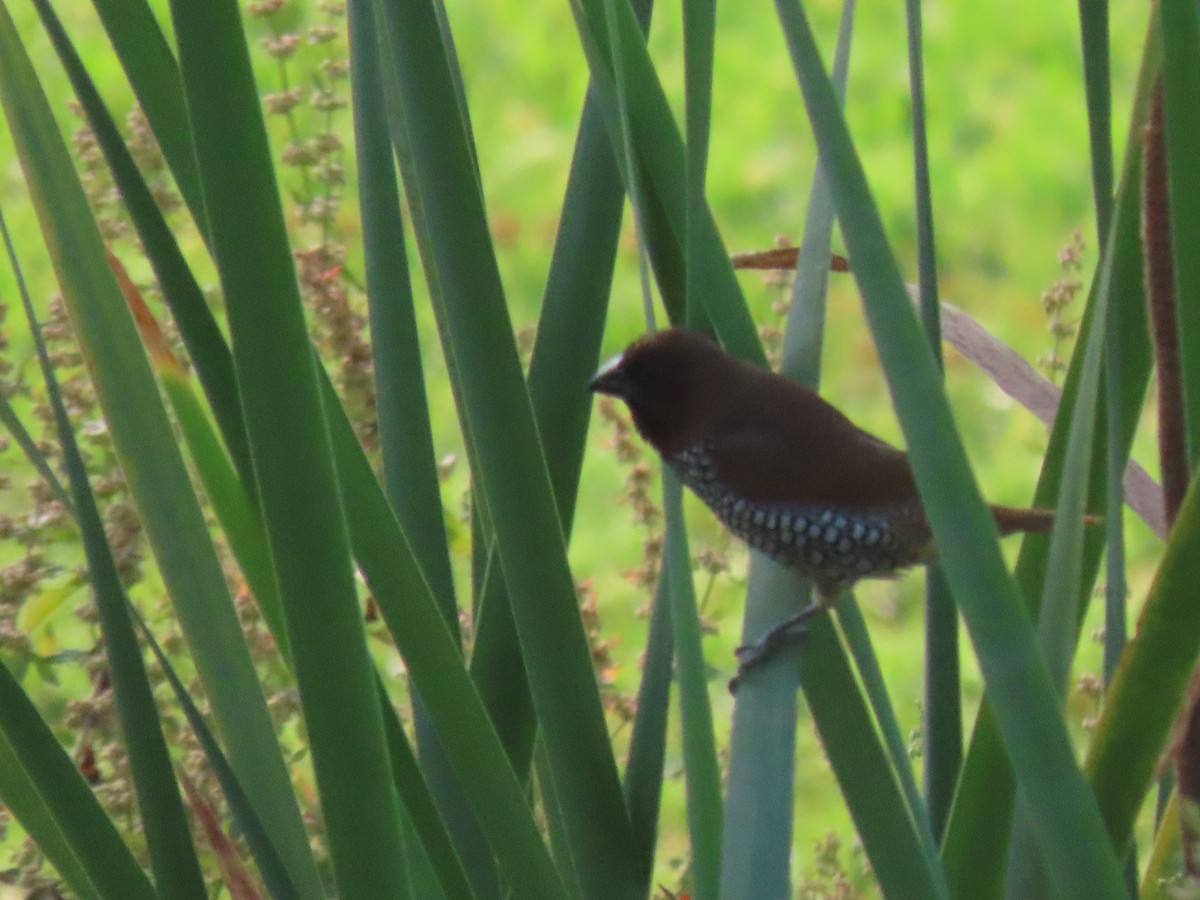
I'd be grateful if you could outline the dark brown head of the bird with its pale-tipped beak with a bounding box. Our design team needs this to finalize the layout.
[588,328,742,454]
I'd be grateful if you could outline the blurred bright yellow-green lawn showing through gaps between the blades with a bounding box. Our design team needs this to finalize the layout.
[0,0,1157,892]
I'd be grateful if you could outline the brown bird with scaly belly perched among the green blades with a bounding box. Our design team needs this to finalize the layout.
[588,329,1054,689]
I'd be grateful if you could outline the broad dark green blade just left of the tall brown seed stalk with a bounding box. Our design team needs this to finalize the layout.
[172,1,406,896]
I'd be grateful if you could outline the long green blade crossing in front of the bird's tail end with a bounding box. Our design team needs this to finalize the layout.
[776,0,1124,896]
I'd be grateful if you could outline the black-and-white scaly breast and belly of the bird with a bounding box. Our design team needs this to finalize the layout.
[667,445,932,589]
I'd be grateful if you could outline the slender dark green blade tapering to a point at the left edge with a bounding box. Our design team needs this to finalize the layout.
[0,206,206,898]
